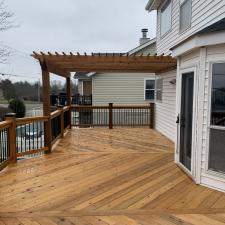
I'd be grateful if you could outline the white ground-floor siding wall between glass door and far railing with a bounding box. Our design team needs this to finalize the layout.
[155,70,177,142]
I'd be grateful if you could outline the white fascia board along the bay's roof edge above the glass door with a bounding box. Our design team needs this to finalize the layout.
[172,31,225,57]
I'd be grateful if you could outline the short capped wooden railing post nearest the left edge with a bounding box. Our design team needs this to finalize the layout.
[5,113,17,163]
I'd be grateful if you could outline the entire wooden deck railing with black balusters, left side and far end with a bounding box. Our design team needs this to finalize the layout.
[0,103,154,170]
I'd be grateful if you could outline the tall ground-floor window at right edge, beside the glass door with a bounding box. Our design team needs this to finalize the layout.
[209,63,225,172]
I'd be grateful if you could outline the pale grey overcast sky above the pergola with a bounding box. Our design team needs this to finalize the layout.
[0,0,156,81]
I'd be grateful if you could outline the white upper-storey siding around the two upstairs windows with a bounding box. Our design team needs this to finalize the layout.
[157,0,225,54]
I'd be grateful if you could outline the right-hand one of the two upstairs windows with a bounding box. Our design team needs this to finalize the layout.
[180,0,192,32]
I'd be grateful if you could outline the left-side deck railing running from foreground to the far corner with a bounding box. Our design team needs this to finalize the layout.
[0,107,70,170]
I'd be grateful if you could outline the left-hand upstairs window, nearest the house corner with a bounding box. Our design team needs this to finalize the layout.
[160,0,172,36]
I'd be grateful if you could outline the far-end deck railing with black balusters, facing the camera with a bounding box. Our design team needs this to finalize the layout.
[71,103,154,129]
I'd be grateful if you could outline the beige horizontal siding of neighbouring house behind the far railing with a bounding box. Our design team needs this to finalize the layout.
[92,73,155,105]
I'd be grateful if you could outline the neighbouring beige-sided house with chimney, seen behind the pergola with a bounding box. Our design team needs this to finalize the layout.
[75,29,156,105]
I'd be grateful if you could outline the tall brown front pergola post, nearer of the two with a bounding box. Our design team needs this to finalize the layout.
[40,61,52,153]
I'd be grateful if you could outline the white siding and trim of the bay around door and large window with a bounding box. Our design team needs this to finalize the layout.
[177,44,225,191]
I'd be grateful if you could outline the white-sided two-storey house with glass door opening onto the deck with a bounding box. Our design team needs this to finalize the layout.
[146,0,225,191]
